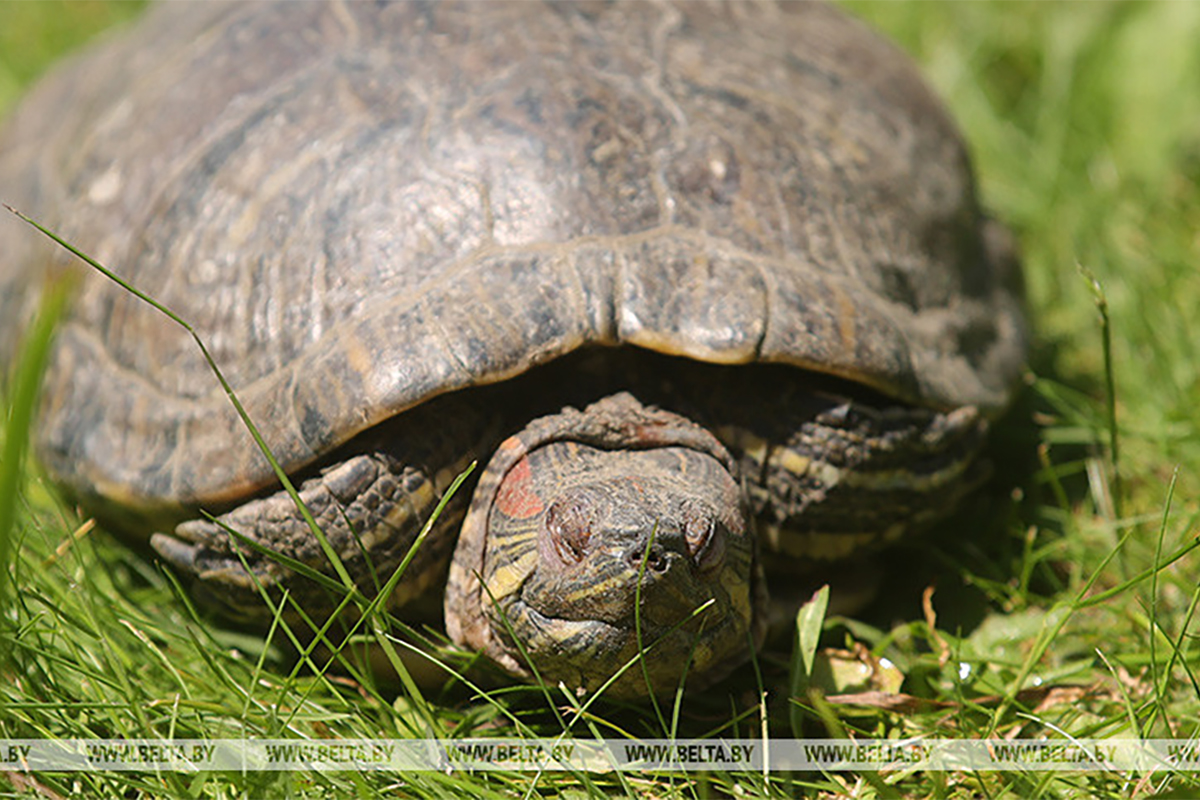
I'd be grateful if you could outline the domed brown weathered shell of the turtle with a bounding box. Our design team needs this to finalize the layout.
[0,2,1025,522]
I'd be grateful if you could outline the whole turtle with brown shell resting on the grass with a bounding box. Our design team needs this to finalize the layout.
[0,2,1027,697]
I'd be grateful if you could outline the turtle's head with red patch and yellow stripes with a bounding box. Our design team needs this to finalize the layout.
[446,393,762,696]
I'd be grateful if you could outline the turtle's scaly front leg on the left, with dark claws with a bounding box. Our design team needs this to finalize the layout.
[151,452,467,622]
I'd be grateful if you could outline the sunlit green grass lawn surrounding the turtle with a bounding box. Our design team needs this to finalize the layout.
[0,2,1200,798]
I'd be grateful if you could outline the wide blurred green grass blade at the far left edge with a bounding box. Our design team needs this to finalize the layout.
[0,278,71,657]
